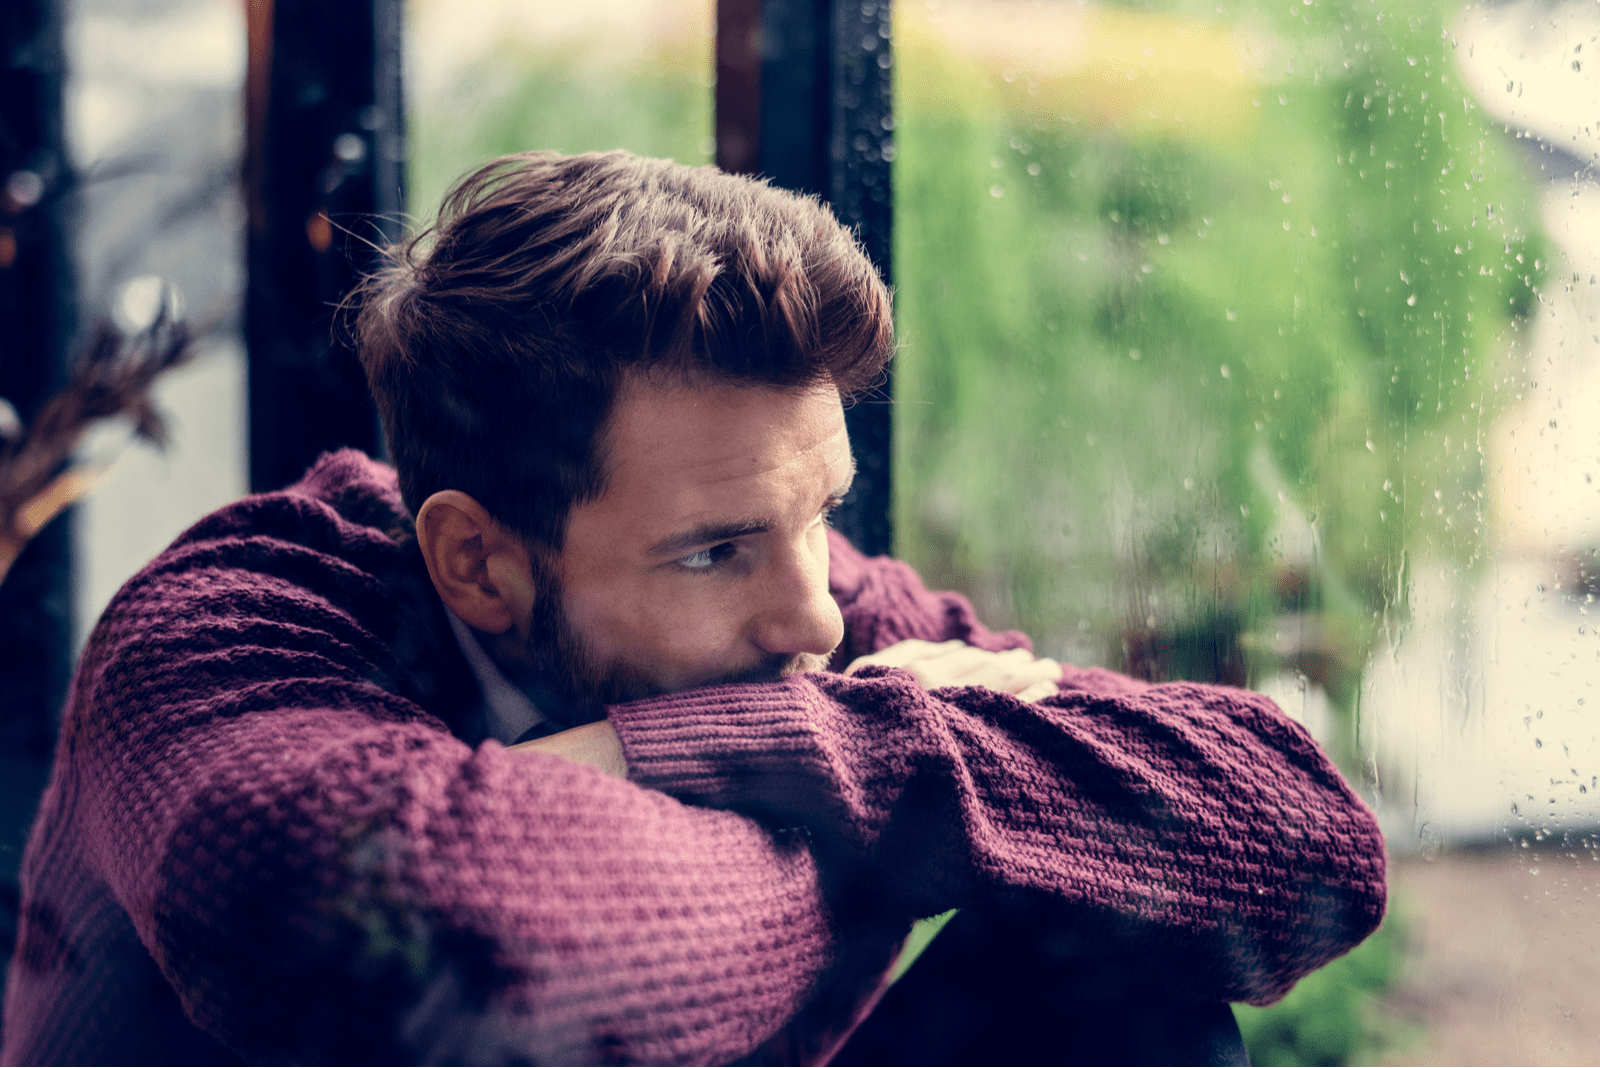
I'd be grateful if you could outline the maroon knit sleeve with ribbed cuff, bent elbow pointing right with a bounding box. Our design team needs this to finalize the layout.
[611,667,1384,1004]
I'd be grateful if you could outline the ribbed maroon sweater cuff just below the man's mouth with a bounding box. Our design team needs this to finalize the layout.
[606,676,830,819]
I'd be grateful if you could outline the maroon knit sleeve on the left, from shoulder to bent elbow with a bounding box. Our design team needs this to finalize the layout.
[58,502,834,1063]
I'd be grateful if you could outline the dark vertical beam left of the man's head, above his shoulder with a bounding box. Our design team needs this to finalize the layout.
[245,0,405,491]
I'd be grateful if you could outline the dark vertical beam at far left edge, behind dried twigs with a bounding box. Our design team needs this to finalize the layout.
[0,0,74,1004]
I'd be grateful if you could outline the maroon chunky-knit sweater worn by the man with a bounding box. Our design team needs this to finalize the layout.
[3,452,1384,1063]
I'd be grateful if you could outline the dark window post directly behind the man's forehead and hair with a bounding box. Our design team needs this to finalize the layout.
[717,0,894,553]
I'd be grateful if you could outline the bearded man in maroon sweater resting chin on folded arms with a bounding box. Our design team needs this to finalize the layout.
[3,153,1384,1063]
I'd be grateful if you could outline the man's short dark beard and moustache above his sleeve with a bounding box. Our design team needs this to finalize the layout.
[526,564,829,729]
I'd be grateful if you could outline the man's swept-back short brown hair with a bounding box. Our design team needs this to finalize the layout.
[355,152,894,550]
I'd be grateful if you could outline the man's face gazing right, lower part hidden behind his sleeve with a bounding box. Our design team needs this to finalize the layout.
[528,379,854,703]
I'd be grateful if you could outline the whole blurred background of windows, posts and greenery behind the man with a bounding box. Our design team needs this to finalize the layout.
[0,0,1600,1063]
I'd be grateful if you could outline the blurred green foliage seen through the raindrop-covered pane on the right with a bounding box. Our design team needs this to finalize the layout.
[896,0,1544,708]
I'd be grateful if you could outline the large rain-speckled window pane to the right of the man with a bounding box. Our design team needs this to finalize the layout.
[894,0,1600,1063]
